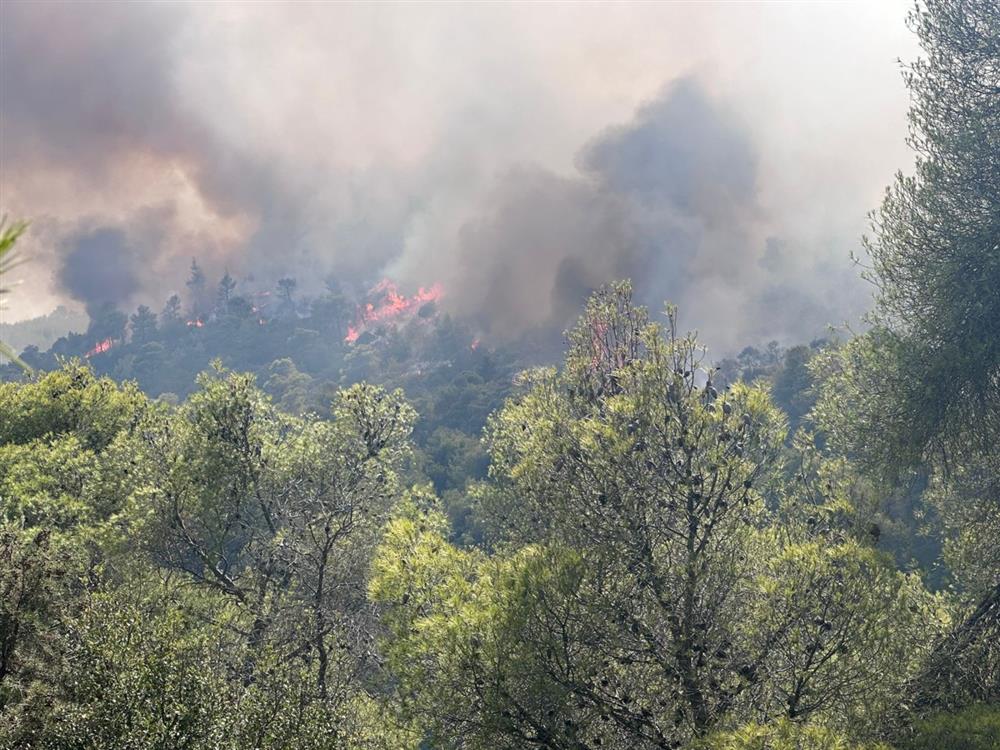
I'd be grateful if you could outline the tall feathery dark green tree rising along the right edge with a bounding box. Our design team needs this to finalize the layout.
[828,0,1000,467]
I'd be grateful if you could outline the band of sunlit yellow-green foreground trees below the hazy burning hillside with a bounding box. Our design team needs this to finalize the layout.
[0,285,998,748]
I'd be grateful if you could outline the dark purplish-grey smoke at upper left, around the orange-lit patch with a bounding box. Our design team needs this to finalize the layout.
[0,1,400,305]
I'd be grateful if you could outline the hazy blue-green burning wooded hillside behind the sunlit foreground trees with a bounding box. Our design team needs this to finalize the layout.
[2,261,832,559]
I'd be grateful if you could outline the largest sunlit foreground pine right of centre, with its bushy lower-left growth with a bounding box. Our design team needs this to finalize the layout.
[369,285,946,748]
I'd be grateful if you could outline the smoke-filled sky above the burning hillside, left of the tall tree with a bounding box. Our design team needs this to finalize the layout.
[0,1,915,350]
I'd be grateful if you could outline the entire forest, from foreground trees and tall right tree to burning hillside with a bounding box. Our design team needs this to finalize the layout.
[0,0,1000,750]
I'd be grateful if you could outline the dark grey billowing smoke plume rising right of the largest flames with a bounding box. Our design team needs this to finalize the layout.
[446,78,761,336]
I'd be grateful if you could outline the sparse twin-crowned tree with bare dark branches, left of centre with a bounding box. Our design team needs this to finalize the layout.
[133,371,414,746]
